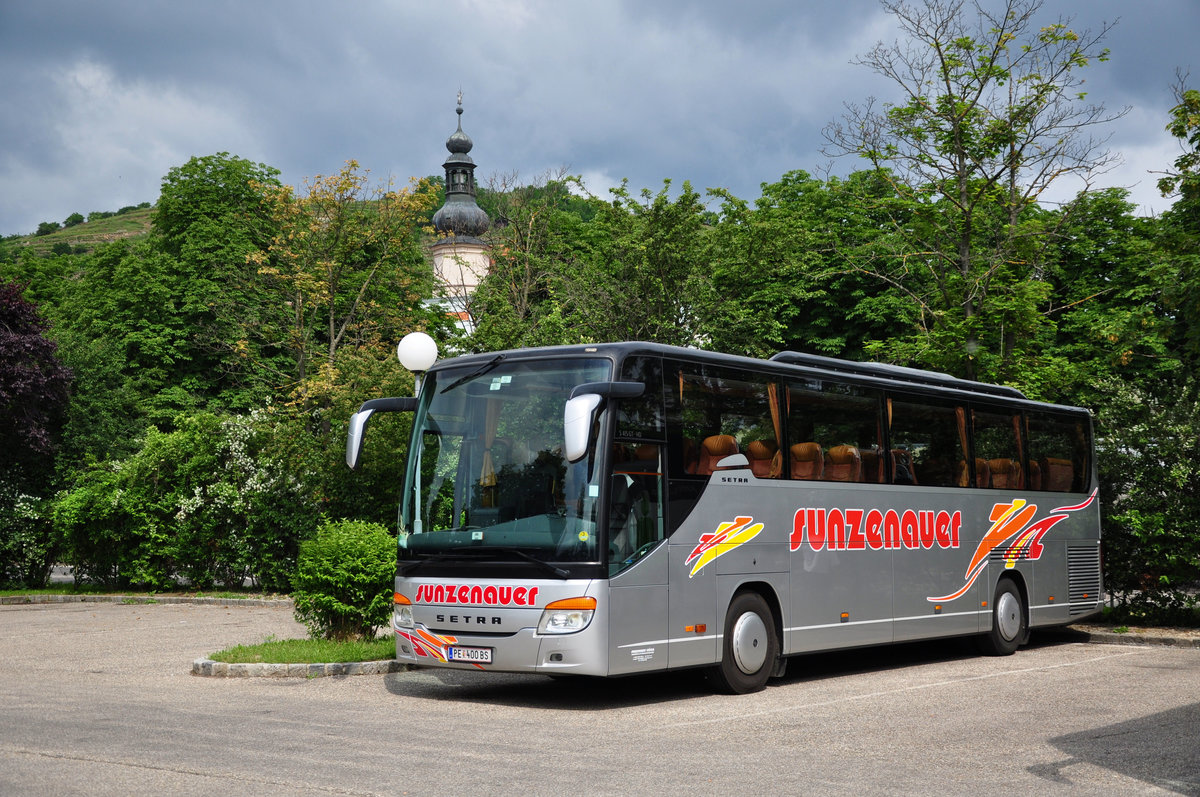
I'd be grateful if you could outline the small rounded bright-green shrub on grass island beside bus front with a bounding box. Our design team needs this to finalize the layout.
[292,520,396,640]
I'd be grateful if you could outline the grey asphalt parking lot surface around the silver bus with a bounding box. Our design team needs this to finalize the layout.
[0,604,1200,795]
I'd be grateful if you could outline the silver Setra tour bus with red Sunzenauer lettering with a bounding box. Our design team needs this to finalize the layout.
[347,342,1103,693]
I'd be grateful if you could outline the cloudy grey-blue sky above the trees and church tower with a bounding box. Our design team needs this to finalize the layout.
[0,0,1200,235]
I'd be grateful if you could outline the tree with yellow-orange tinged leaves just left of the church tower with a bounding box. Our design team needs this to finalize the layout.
[248,161,434,406]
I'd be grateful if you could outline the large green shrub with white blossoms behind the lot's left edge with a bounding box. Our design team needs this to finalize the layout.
[54,411,320,592]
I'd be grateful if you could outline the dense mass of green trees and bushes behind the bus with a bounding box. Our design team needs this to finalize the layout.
[0,1,1200,619]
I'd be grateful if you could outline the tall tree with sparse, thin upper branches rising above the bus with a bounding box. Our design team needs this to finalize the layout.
[826,0,1123,378]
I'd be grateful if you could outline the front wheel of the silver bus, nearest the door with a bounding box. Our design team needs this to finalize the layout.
[708,592,779,695]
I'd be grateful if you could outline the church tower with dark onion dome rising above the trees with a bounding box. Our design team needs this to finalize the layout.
[432,91,492,331]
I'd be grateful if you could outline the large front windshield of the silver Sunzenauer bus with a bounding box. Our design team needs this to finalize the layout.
[400,359,612,562]
